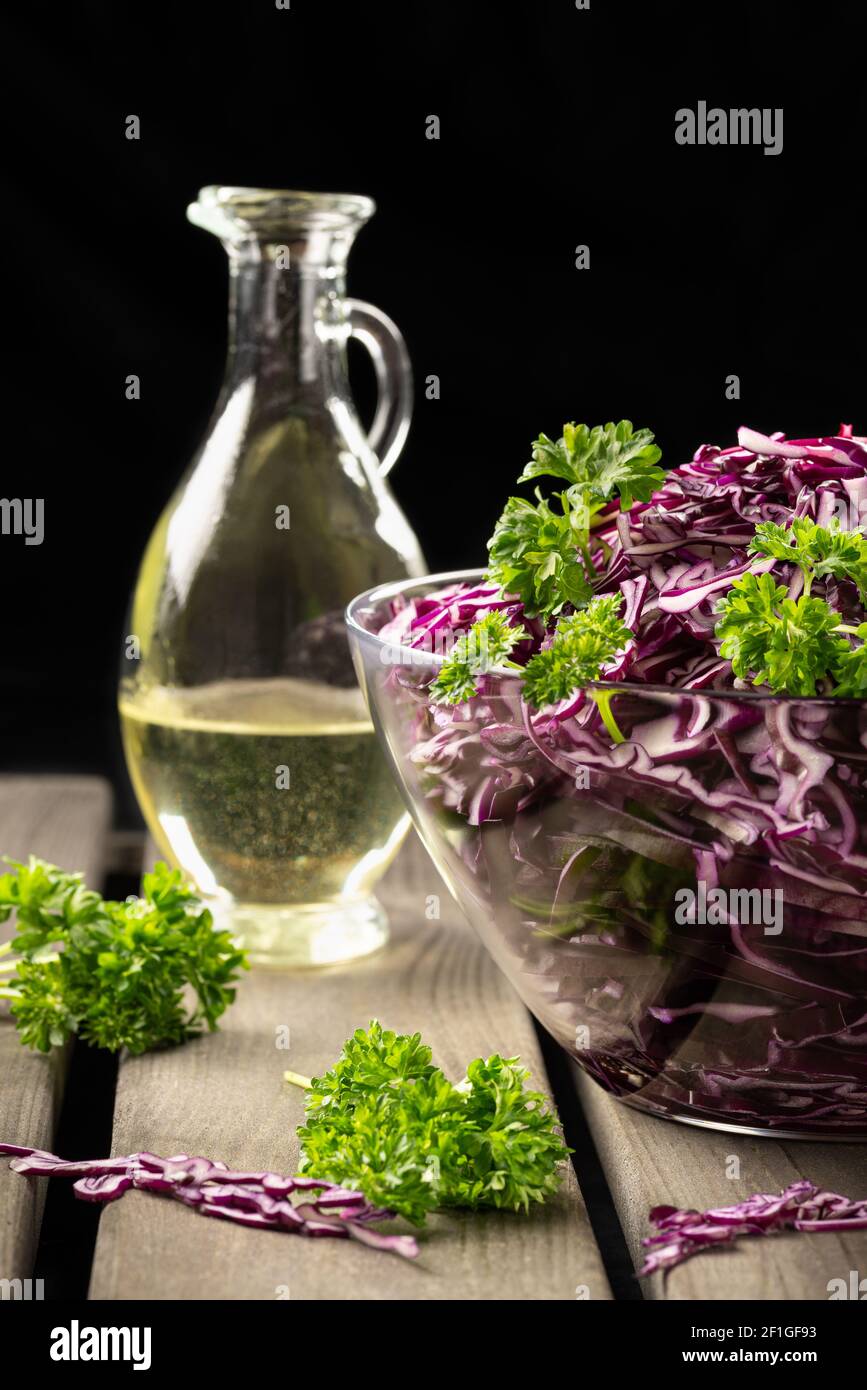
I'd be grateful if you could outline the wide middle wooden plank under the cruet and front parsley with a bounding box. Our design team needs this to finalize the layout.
[90,835,610,1300]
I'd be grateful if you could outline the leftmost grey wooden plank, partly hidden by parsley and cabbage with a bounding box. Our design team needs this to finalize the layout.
[0,777,111,1279]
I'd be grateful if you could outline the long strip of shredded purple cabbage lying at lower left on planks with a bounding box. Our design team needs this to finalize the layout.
[0,1144,418,1258]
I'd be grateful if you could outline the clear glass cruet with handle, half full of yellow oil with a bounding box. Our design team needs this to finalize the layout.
[119,188,425,965]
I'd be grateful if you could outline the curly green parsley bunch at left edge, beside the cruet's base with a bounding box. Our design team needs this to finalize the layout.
[0,856,246,1054]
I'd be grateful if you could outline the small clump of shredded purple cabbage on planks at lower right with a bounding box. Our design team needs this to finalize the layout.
[638,1179,867,1277]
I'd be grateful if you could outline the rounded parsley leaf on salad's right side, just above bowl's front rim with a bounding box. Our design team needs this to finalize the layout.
[716,574,849,695]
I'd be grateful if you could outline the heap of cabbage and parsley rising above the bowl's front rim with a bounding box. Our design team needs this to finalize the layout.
[379,421,867,706]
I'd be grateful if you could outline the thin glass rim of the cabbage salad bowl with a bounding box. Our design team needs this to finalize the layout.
[343,569,867,709]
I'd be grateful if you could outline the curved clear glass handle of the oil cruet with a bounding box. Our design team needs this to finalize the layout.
[343,299,413,478]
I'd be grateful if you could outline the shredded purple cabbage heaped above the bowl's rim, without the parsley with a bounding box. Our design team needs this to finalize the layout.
[379,425,867,686]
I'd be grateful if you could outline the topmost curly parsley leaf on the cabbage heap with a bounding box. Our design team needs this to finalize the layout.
[518,420,664,510]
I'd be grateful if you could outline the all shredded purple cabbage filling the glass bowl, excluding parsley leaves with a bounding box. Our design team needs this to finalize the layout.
[368,425,867,1137]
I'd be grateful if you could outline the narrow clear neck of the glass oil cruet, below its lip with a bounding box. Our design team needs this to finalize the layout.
[226,243,346,391]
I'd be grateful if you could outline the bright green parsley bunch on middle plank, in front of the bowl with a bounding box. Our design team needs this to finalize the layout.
[286,1020,570,1226]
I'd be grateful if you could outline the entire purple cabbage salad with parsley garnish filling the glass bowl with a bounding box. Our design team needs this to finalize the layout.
[378,421,867,1134]
